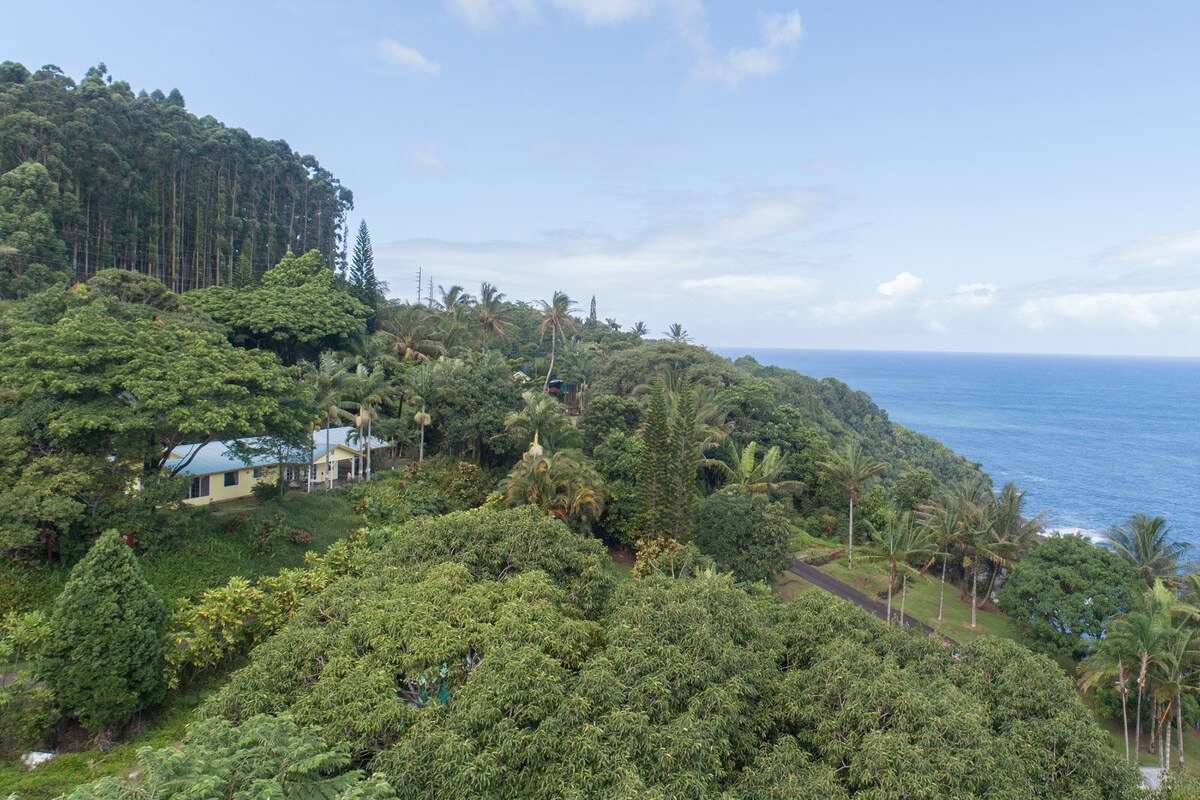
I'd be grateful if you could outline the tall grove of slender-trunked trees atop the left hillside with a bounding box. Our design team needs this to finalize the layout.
[0,61,354,297]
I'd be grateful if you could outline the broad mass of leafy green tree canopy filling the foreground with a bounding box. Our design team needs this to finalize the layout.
[187,510,1133,799]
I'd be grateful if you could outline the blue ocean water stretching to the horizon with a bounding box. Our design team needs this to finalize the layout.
[718,348,1200,546]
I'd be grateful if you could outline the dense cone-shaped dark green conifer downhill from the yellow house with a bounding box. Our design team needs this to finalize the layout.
[41,530,167,730]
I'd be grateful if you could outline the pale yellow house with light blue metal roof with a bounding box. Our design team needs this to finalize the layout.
[167,426,390,505]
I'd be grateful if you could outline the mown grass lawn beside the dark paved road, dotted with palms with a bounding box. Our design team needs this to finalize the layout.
[821,559,1018,644]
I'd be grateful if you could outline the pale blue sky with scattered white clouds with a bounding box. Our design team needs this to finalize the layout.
[0,0,1200,357]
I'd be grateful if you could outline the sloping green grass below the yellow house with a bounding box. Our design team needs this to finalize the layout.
[0,492,361,618]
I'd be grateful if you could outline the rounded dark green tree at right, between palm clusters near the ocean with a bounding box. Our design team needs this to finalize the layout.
[996,536,1141,660]
